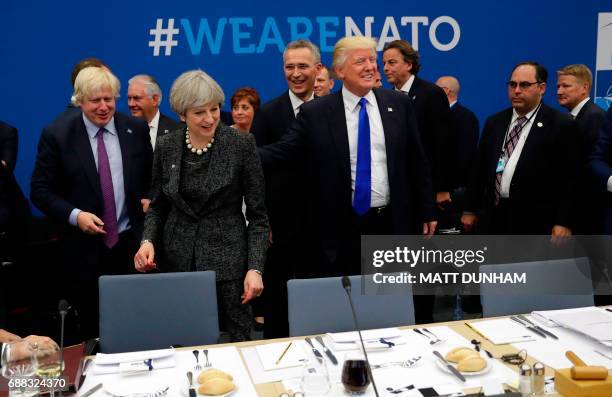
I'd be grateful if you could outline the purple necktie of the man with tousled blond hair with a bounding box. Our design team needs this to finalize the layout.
[97,128,119,248]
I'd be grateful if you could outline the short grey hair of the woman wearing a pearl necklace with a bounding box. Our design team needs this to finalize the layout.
[170,69,225,115]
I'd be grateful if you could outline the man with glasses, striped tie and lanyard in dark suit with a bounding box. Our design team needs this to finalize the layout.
[461,62,584,238]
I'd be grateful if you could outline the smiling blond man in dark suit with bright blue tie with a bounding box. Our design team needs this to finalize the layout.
[260,37,436,318]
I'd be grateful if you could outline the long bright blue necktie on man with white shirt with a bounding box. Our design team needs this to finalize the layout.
[353,98,372,216]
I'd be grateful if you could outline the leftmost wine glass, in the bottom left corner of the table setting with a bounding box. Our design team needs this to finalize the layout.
[0,340,38,396]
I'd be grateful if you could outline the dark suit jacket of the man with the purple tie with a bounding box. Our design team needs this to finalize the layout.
[30,111,152,278]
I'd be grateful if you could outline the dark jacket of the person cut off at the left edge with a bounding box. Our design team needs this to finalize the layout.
[0,121,30,232]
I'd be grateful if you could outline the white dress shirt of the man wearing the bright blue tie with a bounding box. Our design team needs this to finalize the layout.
[342,86,389,208]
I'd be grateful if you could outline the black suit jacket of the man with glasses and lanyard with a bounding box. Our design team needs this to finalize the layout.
[466,104,581,234]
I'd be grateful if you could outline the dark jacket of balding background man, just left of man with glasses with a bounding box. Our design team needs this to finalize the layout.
[451,102,480,187]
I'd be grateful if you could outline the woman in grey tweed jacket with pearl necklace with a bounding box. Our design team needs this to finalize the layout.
[134,70,268,341]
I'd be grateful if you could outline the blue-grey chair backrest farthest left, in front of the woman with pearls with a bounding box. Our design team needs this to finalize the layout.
[99,271,219,353]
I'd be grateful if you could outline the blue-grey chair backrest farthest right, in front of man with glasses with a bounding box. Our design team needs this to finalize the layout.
[480,258,594,317]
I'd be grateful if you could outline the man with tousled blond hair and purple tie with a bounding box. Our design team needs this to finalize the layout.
[31,67,152,339]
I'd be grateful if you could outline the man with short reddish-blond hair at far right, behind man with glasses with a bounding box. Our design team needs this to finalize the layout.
[557,64,606,235]
